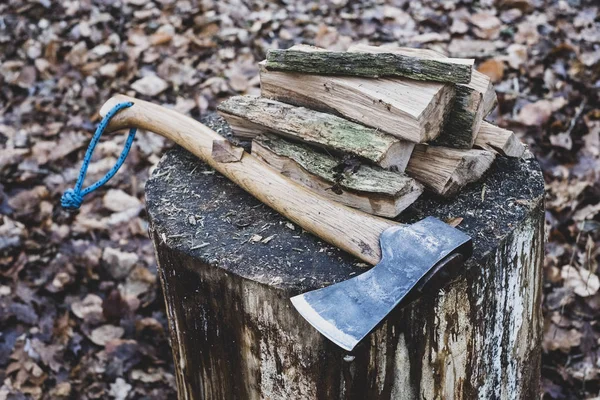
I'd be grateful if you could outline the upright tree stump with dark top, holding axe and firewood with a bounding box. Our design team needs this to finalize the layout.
[146,117,544,399]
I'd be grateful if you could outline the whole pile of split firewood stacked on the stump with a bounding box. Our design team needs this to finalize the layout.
[218,45,524,217]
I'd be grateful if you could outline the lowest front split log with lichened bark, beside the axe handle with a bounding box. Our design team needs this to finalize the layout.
[252,135,423,218]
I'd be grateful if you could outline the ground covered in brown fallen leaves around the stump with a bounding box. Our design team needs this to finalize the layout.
[0,0,600,399]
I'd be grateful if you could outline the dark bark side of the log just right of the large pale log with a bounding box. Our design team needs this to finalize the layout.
[431,85,483,149]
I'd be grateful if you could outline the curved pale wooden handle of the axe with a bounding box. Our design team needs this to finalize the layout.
[100,95,397,265]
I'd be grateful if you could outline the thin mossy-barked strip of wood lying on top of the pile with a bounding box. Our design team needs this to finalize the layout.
[266,50,473,83]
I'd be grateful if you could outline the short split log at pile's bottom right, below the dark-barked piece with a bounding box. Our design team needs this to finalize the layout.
[406,145,495,196]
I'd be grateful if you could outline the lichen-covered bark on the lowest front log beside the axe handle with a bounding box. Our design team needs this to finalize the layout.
[254,134,415,197]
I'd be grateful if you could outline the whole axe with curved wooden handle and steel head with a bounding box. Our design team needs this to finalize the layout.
[100,95,472,350]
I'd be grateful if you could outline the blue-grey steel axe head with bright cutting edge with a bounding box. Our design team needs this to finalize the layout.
[291,217,472,351]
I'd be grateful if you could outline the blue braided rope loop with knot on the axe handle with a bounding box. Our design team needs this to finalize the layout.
[60,101,137,210]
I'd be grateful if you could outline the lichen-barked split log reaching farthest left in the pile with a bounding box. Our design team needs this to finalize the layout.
[218,96,414,171]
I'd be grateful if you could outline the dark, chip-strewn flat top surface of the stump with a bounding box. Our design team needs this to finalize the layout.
[146,115,544,293]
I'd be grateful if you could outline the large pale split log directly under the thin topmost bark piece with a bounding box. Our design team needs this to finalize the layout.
[259,61,455,143]
